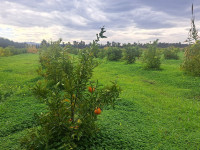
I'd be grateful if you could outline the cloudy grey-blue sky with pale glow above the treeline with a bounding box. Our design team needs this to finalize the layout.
[0,0,200,43]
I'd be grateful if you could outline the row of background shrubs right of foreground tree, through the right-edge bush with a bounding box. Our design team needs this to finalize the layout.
[94,40,200,76]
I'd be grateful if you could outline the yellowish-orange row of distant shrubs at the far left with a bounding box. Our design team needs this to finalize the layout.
[0,46,38,57]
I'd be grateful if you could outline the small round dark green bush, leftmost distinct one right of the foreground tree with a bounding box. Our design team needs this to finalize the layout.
[107,47,122,61]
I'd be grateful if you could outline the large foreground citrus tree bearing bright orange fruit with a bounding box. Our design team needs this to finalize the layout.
[21,29,120,149]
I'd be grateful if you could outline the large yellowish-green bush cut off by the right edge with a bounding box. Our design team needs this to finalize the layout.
[181,41,200,76]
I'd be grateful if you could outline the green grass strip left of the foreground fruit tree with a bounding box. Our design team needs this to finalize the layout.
[0,54,45,150]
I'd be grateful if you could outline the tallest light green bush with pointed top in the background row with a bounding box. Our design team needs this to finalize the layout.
[143,40,161,69]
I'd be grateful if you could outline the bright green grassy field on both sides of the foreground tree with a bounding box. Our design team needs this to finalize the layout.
[0,54,200,150]
